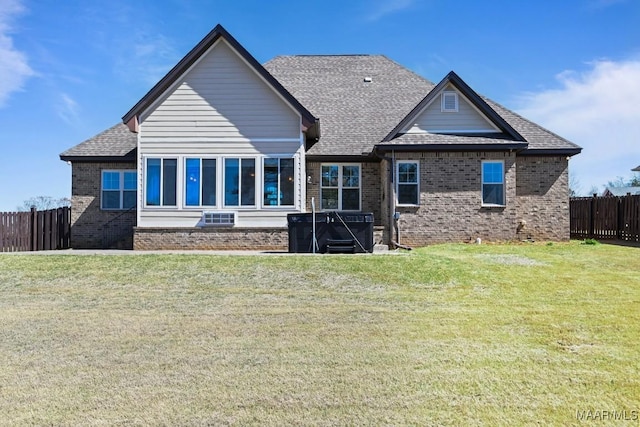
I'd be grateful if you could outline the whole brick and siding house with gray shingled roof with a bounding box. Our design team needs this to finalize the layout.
[60,25,581,250]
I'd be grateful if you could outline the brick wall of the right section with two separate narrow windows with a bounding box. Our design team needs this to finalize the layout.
[388,152,517,246]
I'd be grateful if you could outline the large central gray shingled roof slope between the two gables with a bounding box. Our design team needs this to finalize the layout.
[264,55,435,156]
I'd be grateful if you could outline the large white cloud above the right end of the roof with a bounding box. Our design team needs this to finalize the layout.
[518,59,640,194]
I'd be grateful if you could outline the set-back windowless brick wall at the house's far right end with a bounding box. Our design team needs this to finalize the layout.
[516,156,569,240]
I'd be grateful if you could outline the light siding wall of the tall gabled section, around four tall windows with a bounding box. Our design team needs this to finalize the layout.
[138,39,306,228]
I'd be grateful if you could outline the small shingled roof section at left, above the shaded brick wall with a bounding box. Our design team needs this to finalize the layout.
[60,123,138,162]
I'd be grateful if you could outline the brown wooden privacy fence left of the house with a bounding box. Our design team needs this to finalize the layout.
[0,207,71,252]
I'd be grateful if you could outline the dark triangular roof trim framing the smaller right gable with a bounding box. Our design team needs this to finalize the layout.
[383,71,525,142]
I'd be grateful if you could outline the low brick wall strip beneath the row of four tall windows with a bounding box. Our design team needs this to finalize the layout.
[133,227,289,251]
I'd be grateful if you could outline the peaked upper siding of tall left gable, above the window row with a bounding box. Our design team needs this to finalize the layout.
[140,40,300,141]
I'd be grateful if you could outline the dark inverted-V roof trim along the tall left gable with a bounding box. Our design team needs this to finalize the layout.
[122,24,319,138]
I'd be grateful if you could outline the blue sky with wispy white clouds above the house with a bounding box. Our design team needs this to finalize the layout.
[0,0,640,211]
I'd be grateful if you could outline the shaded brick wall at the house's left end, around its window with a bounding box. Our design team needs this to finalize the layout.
[71,162,136,249]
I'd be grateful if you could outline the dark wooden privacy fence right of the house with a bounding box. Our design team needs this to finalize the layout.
[569,195,640,242]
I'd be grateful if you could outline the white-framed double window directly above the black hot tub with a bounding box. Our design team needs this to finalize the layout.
[320,164,360,211]
